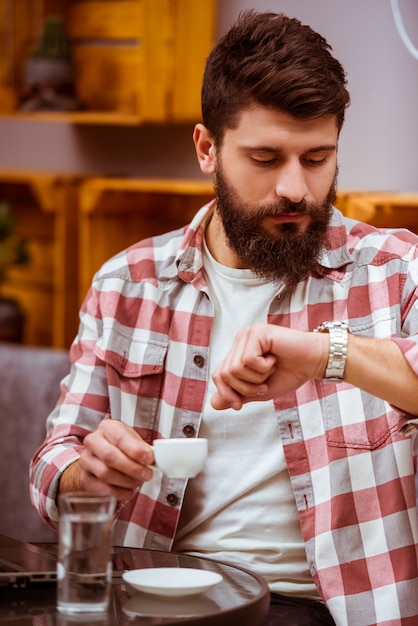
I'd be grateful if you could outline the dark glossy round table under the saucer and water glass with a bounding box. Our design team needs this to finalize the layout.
[0,548,270,626]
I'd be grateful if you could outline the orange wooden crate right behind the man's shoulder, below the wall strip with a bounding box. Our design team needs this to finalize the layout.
[79,178,214,299]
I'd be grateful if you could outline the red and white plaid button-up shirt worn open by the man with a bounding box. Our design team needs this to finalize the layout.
[31,205,418,626]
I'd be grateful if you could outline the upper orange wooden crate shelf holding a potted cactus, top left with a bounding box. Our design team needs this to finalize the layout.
[0,0,216,124]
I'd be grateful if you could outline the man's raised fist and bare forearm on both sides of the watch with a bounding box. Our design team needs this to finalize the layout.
[211,323,418,416]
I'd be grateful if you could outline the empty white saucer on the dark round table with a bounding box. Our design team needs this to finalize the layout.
[122,567,222,597]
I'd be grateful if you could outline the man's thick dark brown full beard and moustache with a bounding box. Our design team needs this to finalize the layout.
[215,163,337,283]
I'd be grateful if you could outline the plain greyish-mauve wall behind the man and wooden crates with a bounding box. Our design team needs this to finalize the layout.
[0,0,418,190]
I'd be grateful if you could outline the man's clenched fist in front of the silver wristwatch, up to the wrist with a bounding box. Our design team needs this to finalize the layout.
[211,323,329,409]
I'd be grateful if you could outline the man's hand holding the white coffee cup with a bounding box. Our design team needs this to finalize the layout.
[67,419,154,500]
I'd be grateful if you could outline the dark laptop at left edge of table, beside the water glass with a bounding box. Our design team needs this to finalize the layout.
[0,534,57,589]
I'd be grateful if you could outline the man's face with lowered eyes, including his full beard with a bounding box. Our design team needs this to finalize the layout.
[204,108,338,282]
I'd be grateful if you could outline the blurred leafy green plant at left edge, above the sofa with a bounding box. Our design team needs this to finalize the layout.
[0,200,30,284]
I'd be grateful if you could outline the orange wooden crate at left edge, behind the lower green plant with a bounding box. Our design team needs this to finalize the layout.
[0,170,79,347]
